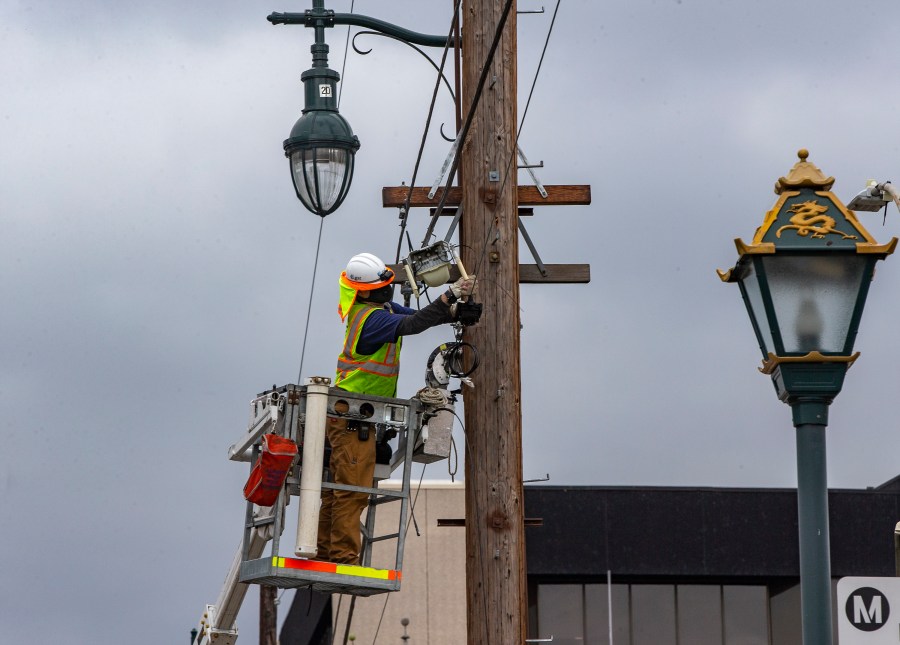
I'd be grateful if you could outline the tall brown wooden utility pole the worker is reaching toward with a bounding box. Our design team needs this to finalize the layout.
[460,0,528,645]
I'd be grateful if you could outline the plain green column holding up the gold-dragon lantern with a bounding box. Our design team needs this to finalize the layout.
[791,398,833,645]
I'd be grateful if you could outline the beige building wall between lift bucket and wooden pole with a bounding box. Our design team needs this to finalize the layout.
[332,481,466,645]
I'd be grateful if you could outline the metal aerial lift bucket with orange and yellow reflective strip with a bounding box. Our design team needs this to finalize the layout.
[230,377,451,596]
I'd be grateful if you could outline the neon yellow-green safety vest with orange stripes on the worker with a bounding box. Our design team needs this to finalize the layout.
[334,303,401,397]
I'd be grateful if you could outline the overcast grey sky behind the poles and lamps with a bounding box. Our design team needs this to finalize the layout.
[0,0,900,645]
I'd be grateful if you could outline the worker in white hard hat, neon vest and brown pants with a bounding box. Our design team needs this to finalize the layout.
[316,253,481,564]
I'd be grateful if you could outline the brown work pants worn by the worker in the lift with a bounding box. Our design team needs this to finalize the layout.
[316,417,375,564]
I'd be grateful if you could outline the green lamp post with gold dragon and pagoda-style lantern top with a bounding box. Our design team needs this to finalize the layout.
[718,150,897,645]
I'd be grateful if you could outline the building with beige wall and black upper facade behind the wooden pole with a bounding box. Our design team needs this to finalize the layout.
[281,478,900,645]
